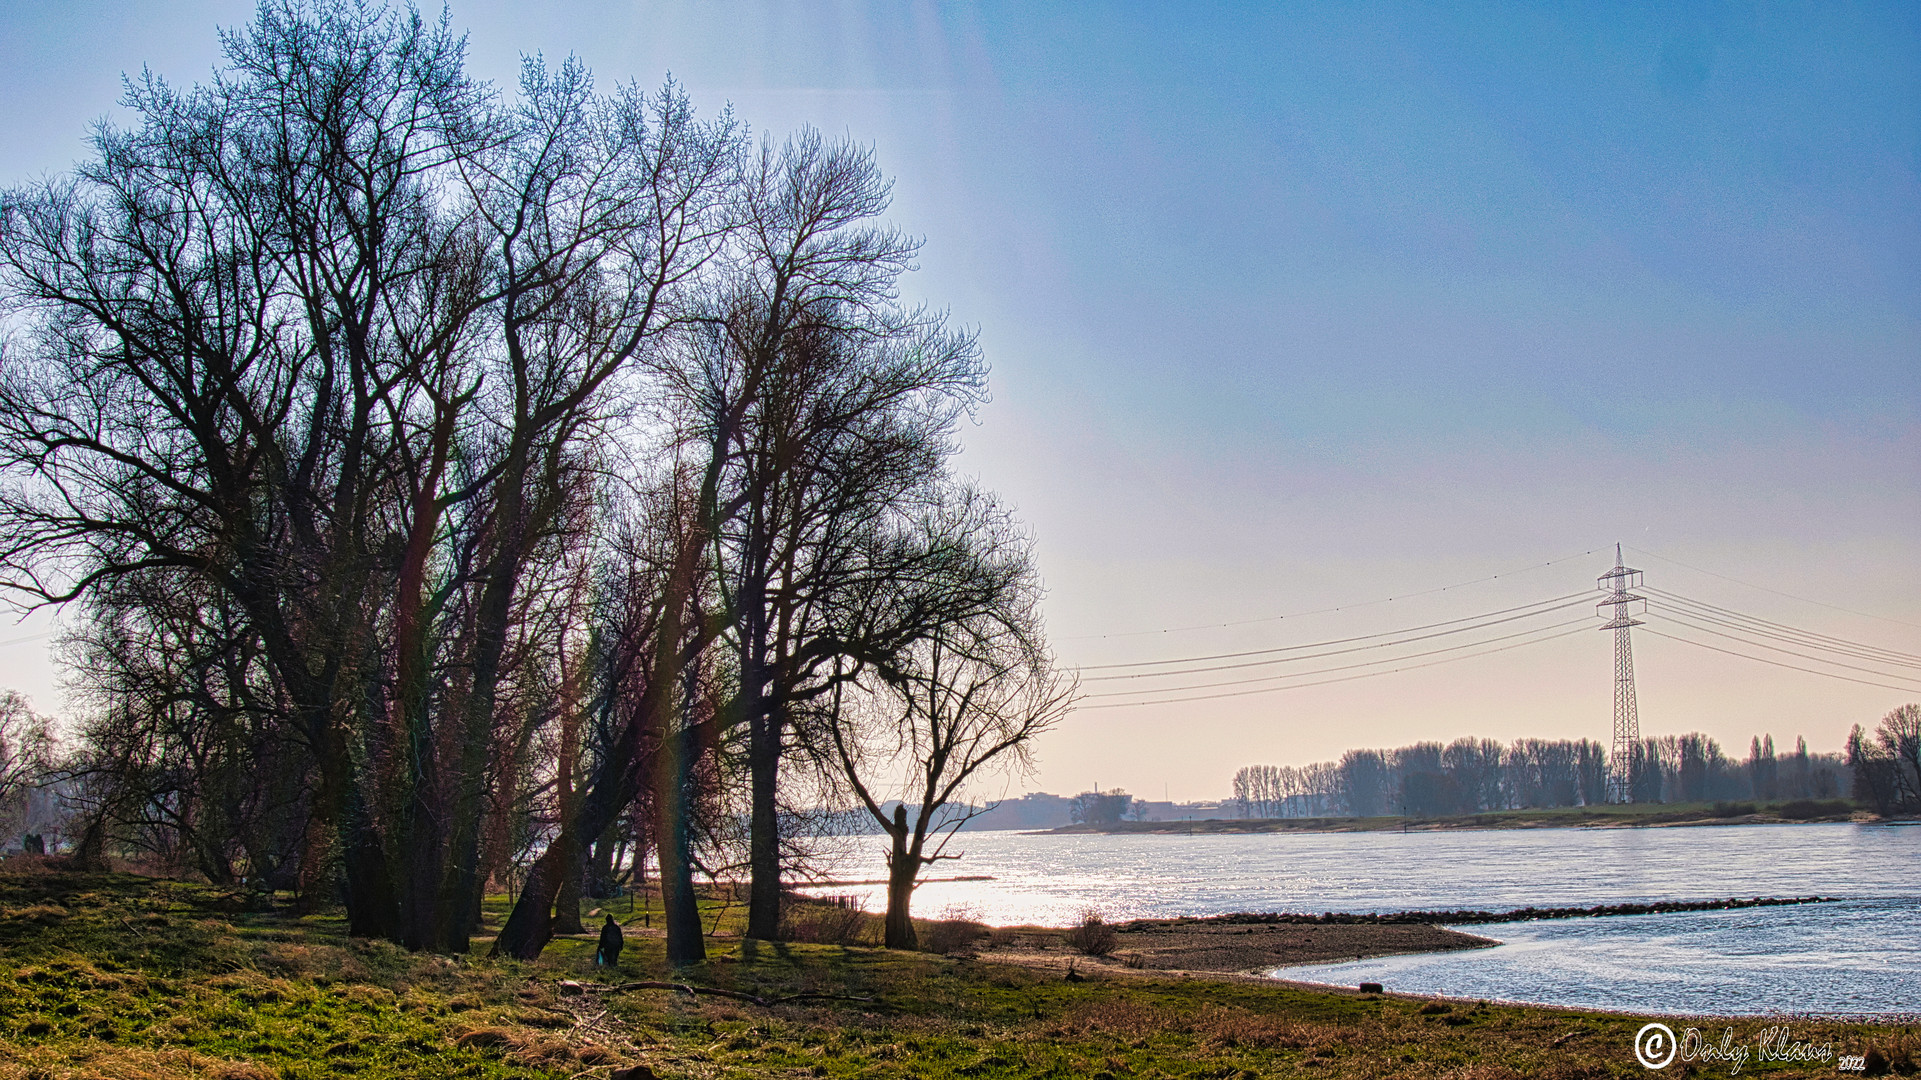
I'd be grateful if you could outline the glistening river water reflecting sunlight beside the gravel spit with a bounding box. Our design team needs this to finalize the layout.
[799,824,1921,1015]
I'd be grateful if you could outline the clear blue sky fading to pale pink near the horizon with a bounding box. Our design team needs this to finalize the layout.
[0,0,1921,799]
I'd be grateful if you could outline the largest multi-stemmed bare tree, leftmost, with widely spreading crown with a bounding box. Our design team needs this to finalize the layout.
[0,0,738,951]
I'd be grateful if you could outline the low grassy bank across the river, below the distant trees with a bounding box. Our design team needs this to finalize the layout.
[1051,799,1873,834]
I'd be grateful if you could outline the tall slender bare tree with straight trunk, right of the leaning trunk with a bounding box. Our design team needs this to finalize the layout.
[699,129,985,938]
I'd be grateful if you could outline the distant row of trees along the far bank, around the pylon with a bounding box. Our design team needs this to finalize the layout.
[1233,722,1842,817]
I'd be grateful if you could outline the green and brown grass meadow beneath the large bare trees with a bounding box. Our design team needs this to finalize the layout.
[0,861,1915,1080]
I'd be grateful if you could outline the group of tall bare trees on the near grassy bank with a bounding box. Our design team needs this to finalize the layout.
[0,0,1072,963]
